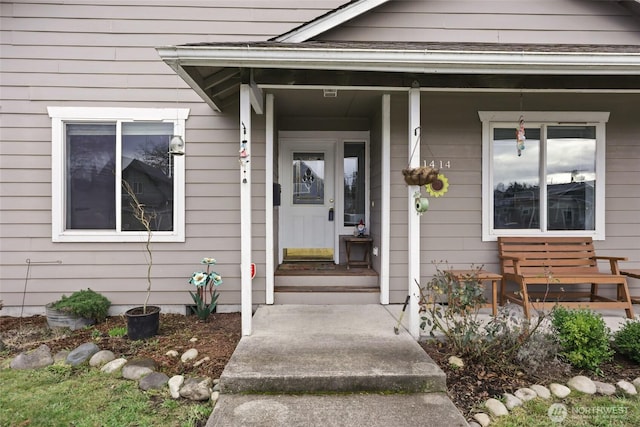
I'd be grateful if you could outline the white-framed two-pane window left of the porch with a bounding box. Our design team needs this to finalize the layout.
[49,107,188,241]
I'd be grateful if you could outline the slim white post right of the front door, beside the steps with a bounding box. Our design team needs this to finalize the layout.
[380,93,391,304]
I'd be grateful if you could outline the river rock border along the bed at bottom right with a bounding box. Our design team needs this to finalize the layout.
[469,375,640,427]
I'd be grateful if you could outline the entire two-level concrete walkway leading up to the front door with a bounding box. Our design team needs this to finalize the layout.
[207,304,467,427]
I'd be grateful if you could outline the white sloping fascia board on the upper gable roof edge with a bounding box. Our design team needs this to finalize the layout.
[273,0,389,43]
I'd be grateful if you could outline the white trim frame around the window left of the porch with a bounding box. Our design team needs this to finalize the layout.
[47,107,189,242]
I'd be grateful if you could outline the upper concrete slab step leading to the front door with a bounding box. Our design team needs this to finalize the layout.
[220,305,446,393]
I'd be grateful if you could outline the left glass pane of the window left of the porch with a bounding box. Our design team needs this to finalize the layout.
[65,123,116,230]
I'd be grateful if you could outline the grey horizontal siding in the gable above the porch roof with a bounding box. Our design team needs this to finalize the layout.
[318,0,640,45]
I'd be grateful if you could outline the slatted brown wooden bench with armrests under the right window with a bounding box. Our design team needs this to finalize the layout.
[498,237,633,319]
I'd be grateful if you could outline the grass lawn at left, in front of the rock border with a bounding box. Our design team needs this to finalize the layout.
[0,365,212,427]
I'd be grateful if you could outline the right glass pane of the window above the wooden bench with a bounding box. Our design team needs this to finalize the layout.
[546,126,596,230]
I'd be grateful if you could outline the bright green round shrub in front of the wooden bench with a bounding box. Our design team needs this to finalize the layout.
[551,306,614,373]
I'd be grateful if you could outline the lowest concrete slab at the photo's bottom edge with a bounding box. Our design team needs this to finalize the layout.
[206,393,468,427]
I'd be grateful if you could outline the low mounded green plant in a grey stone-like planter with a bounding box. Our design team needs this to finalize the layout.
[45,288,111,331]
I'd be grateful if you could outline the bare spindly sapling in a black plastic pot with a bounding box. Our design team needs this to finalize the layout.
[122,180,160,340]
